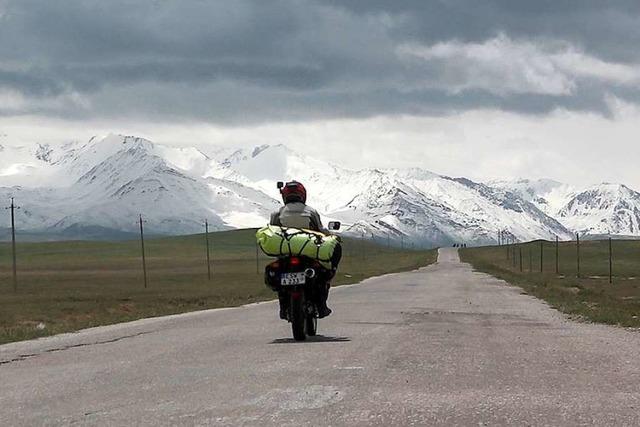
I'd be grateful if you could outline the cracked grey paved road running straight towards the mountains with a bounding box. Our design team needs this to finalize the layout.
[0,250,640,426]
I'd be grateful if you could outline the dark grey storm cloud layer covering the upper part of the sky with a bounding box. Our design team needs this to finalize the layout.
[0,0,640,124]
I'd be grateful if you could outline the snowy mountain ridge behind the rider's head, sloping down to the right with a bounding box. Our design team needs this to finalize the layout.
[218,146,570,244]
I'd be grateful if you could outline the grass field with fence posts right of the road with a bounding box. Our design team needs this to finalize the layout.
[460,240,640,327]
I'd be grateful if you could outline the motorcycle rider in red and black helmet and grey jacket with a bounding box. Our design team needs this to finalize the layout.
[270,181,340,319]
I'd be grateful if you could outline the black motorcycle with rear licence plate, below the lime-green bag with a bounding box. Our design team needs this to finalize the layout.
[264,221,340,341]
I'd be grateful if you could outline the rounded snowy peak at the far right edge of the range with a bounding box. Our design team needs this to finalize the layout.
[558,184,640,236]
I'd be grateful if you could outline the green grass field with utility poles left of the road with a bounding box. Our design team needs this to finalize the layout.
[0,230,436,343]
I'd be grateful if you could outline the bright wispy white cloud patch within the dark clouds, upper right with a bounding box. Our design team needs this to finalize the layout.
[397,34,640,95]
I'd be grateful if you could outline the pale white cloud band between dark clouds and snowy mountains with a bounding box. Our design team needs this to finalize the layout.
[0,97,640,190]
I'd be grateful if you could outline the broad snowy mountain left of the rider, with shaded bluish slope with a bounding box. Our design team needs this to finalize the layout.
[0,135,278,234]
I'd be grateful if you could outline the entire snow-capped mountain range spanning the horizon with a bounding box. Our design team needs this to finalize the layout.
[0,135,640,244]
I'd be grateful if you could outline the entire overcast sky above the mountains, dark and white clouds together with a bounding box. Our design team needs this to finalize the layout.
[0,0,640,189]
